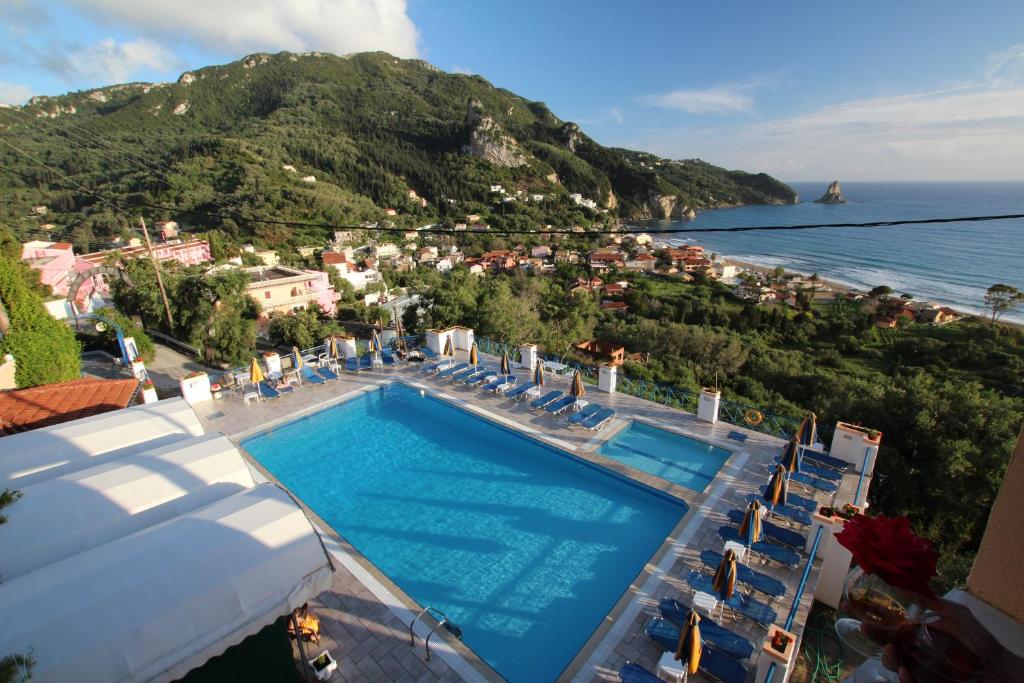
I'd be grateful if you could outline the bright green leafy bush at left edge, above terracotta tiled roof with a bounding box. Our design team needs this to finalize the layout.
[0,257,81,387]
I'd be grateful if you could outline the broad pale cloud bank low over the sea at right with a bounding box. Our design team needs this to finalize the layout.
[630,83,1024,180]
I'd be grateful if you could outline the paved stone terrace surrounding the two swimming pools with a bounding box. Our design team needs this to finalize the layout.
[197,354,856,683]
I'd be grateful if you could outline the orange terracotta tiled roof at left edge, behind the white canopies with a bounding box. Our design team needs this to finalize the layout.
[0,378,138,436]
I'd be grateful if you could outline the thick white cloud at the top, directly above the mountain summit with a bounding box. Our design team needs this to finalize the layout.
[69,0,419,57]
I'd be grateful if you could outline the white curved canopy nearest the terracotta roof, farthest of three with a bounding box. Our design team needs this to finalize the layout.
[0,398,203,488]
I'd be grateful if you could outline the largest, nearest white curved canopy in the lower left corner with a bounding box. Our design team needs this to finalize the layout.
[0,484,331,683]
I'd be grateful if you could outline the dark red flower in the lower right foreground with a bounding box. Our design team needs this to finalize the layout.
[836,515,938,596]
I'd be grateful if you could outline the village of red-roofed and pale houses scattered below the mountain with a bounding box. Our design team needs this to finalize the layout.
[22,208,958,329]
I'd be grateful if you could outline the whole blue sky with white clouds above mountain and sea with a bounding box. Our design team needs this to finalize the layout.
[0,0,1024,181]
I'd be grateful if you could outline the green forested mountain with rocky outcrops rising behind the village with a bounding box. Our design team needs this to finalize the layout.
[0,52,796,247]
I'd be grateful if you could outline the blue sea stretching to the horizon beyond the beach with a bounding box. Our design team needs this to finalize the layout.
[644,181,1024,323]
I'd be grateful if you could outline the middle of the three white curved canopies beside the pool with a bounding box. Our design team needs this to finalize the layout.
[0,433,255,581]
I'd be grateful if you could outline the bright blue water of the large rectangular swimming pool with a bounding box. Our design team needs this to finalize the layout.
[243,384,686,682]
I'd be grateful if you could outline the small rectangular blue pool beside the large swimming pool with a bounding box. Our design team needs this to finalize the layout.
[597,420,730,492]
